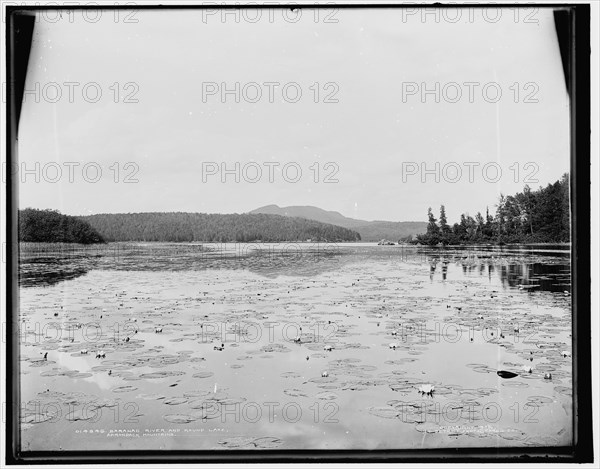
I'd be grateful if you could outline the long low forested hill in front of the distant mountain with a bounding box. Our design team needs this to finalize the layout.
[80,212,360,242]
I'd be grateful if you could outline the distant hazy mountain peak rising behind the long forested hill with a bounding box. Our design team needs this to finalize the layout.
[249,205,427,241]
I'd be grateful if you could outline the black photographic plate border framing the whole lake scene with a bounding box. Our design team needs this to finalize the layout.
[3,3,597,464]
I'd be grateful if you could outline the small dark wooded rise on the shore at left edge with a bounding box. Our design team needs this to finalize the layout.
[19,208,104,244]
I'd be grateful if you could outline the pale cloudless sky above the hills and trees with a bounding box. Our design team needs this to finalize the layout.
[18,8,570,223]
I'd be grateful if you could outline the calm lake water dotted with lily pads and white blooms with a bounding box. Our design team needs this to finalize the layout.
[19,243,573,451]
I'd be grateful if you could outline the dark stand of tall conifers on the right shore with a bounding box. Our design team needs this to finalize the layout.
[413,174,570,245]
